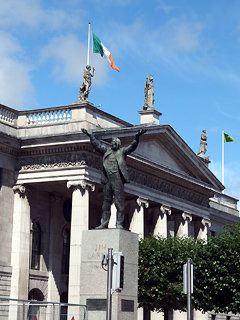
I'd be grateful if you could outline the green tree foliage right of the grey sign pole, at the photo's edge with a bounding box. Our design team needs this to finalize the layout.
[193,223,240,313]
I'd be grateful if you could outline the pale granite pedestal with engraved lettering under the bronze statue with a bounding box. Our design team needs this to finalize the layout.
[80,229,138,320]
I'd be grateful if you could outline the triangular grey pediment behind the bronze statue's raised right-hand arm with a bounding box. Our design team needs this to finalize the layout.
[129,125,224,190]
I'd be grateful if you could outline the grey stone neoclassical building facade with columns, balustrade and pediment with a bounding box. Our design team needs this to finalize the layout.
[0,101,239,320]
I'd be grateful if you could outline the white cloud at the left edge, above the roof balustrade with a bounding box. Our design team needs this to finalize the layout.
[0,33,35,109]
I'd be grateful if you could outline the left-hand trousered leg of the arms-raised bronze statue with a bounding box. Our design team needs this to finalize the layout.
[97,181,112,229]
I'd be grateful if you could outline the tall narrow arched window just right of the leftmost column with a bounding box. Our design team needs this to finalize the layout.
[31,222,41,270]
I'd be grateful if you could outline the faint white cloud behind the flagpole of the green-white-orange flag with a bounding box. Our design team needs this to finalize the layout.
[41,34,108,85]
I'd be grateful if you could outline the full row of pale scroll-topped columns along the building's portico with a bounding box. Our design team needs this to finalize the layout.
[11,179,211,320]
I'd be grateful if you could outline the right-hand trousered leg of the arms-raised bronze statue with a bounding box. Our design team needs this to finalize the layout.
[113,175,125,229]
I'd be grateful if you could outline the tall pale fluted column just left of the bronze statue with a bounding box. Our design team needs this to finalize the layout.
[67,180,95,304]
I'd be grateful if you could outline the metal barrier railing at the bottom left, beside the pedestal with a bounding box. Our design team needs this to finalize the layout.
[0,297,88,320]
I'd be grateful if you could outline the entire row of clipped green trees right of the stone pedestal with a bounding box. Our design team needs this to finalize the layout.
[138,224,240,313]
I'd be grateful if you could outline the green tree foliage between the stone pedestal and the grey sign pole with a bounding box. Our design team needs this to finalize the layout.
[138,235,202,312]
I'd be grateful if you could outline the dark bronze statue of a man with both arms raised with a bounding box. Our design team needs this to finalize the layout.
[82,129,147,229]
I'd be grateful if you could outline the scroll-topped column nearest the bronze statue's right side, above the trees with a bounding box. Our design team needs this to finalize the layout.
[129,197,149,238]
